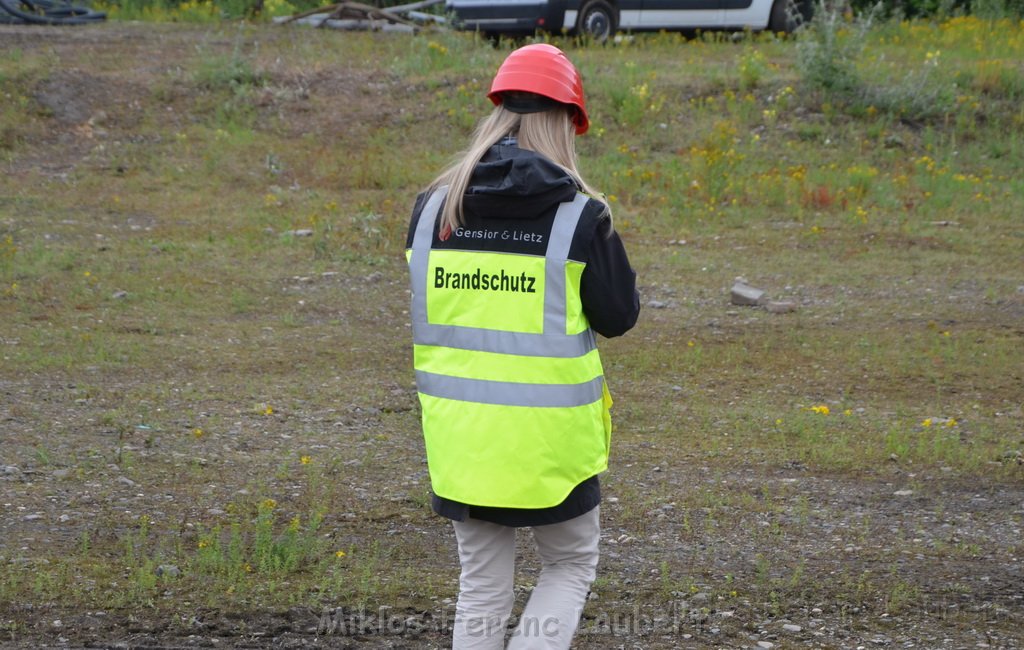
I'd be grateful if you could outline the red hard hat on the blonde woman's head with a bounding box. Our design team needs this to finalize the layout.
[487,43,590,135]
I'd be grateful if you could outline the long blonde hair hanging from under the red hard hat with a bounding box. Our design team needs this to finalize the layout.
[428,104,611,232]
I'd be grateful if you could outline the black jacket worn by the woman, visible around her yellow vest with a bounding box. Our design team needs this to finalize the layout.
[407,139,640,526]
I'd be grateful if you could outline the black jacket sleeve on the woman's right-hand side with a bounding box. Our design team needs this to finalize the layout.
[580,218,640,338]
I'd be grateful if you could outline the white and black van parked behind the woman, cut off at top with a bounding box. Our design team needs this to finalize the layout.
[445,0,812,41]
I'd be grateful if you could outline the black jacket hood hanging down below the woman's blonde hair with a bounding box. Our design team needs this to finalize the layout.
[463,140,578,219]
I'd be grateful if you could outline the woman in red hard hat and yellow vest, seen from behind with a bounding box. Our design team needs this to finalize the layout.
[407,44,640,650]
